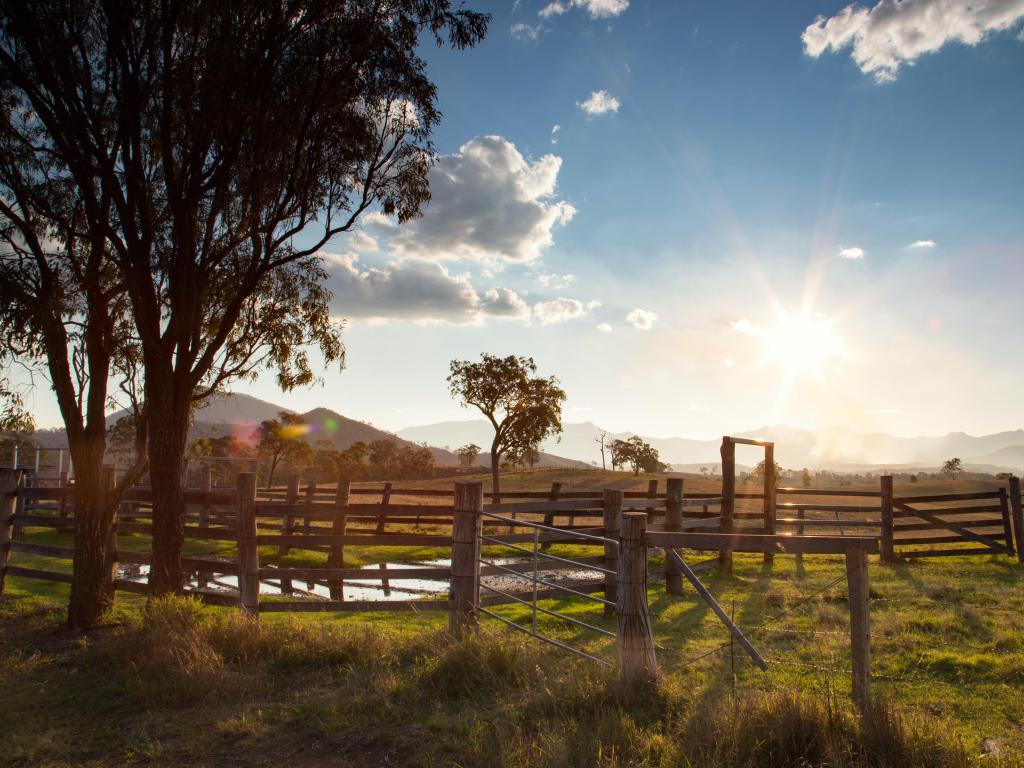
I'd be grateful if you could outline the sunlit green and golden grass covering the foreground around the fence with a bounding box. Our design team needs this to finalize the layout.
[0,471,1024,766]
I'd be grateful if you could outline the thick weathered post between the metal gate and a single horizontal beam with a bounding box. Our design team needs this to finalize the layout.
[615,512,657,683]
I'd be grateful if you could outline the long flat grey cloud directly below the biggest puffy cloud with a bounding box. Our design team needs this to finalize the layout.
[322,253,528,323]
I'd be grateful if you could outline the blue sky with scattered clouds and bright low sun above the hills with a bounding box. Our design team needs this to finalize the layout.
[19,0,1024,436]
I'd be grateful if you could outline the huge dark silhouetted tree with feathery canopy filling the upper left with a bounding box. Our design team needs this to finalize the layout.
[0,0,489,603]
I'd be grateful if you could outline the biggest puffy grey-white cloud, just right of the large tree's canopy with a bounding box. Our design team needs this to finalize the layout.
[392,136,575,263]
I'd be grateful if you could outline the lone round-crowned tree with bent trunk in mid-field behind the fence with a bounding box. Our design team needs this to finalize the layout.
[447,352,565,502]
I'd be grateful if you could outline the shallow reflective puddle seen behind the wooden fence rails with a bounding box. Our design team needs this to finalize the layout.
[118,557,602,600]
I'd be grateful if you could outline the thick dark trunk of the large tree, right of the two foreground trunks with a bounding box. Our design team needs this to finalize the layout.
[146,380,190,595]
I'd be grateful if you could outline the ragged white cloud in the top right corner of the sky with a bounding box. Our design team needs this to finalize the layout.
[802,0,1024,83]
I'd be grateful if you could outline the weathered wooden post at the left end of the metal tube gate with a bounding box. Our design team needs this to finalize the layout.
[449,480,483,638]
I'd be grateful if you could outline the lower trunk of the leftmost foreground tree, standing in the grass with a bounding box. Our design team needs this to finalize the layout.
[68,441,117,631]
